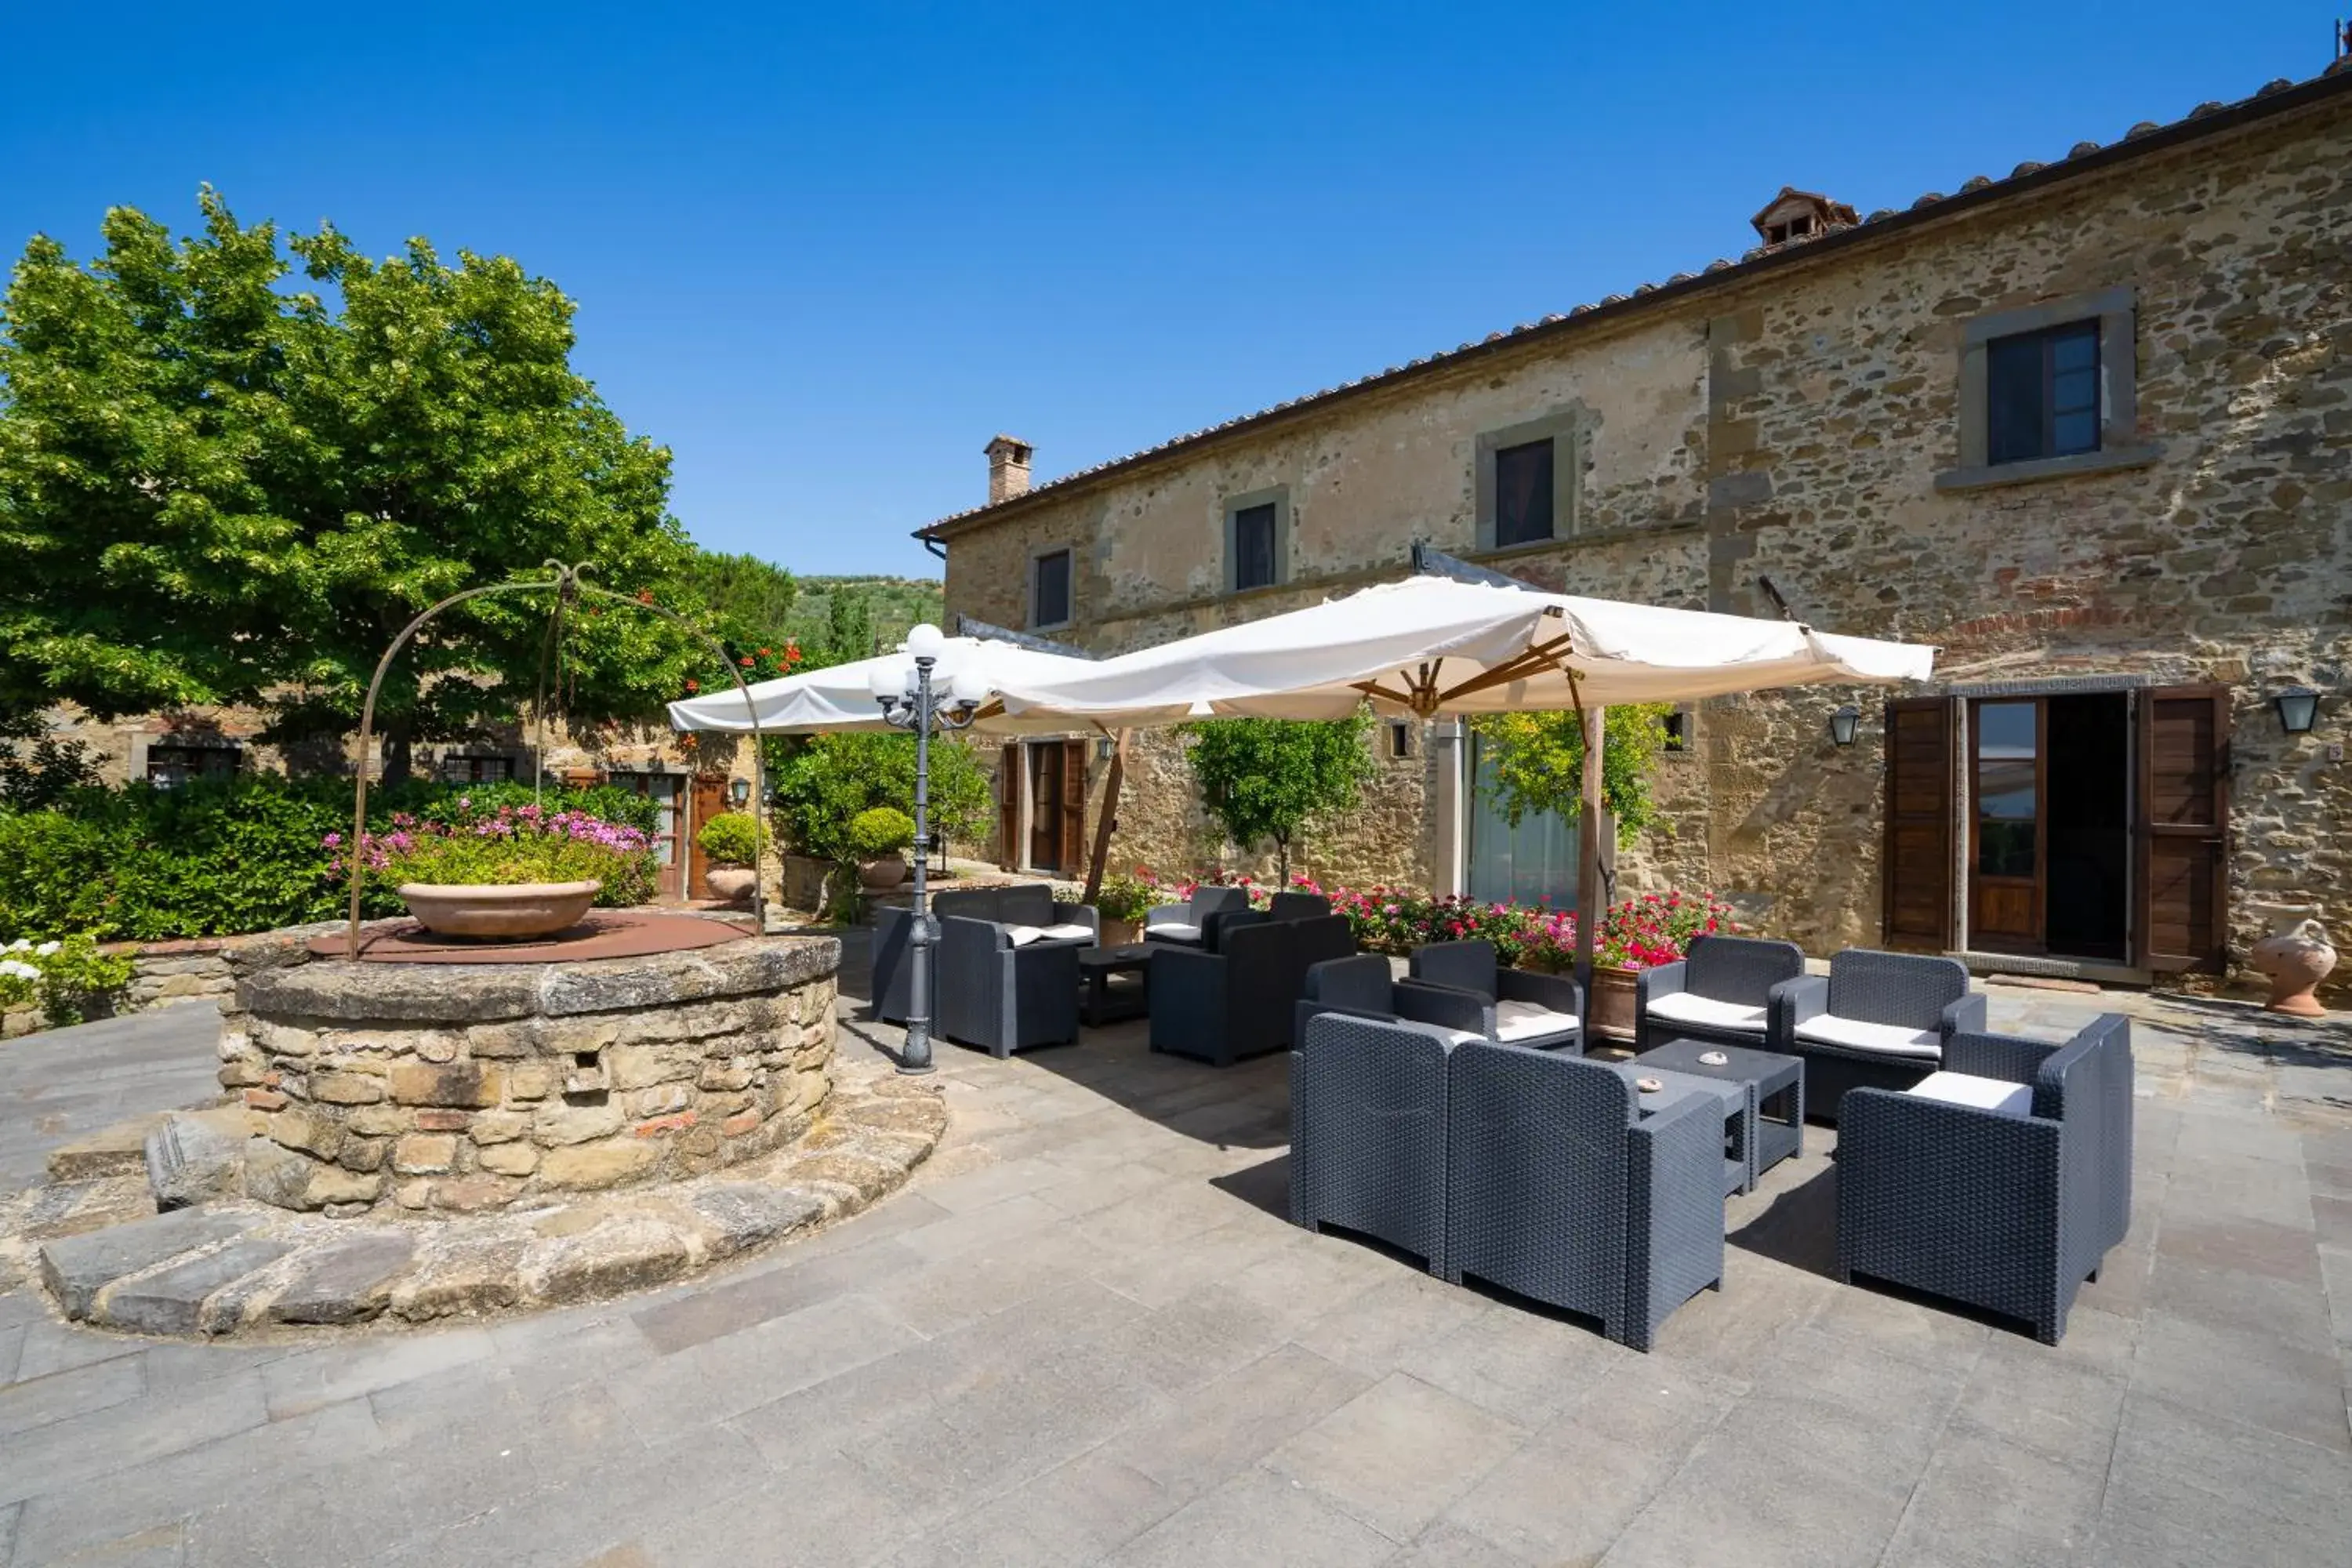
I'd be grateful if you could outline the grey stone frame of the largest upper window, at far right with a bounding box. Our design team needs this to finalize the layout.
[1936,285,2164,492]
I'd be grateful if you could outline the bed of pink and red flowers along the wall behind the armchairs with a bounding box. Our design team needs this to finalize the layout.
[1136,867,1736,973]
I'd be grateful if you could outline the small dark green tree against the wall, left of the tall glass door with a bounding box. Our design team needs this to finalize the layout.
[1185,713,1374,886]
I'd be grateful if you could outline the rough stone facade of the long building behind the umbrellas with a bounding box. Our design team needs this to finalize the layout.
[929,71,2352,992]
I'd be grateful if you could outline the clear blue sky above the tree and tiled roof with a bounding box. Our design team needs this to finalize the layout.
[0,0,2343,583]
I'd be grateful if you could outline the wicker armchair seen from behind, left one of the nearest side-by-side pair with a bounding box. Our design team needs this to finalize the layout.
[1291,1011,1477,1276]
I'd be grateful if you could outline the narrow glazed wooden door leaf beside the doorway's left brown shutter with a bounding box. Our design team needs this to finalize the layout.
[1969,699,2049,952]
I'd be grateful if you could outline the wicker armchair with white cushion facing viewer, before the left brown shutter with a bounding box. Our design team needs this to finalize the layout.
[1766,947,1985,1121]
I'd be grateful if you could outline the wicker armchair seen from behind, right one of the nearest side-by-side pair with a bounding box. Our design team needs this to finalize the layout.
[1444,1041,1724,1349]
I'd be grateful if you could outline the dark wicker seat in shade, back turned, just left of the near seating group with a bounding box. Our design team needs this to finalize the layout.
[1150,914,1355,1067]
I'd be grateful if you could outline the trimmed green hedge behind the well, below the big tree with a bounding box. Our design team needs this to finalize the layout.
[0,774,659,942]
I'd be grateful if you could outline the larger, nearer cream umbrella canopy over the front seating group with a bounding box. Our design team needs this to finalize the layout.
[997,576,1936,727]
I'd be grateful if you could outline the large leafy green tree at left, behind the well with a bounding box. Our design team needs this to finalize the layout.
[0,188,708,779]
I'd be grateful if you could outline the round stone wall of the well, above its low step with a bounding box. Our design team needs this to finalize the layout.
[221,933,840,1215]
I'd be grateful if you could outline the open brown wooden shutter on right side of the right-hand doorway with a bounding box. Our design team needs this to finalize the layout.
[2136,687,2230,973]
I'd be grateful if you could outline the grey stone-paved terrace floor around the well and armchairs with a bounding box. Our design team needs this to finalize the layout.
[0,945,2352,1568]
